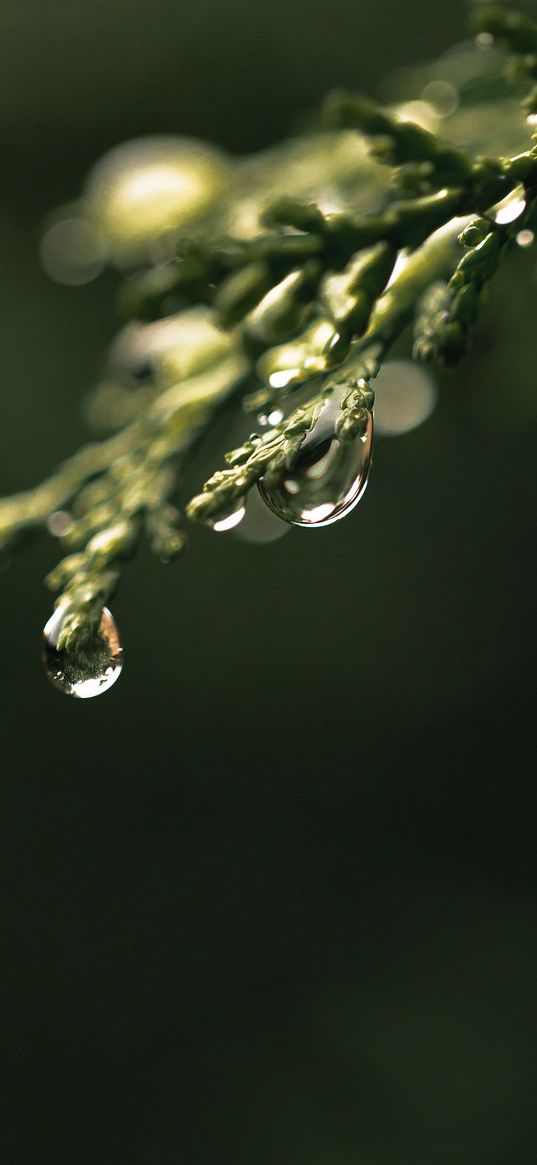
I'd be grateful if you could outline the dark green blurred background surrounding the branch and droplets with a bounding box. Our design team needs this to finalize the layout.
[0,0,537,1165]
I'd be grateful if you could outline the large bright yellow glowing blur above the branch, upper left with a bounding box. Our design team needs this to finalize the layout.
[85,137,228,264]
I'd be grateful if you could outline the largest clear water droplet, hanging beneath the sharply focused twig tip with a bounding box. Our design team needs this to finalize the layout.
[259,395,373,525]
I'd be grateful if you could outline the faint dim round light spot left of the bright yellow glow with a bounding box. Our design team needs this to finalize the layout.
[40,217,107,287]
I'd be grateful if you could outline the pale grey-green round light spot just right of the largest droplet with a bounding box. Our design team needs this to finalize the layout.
[375,360,438,437]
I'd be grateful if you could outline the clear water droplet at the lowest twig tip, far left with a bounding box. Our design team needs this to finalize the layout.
[43,606,123,700]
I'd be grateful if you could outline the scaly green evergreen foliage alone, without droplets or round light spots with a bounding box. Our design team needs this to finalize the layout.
[0,6,537,689]
